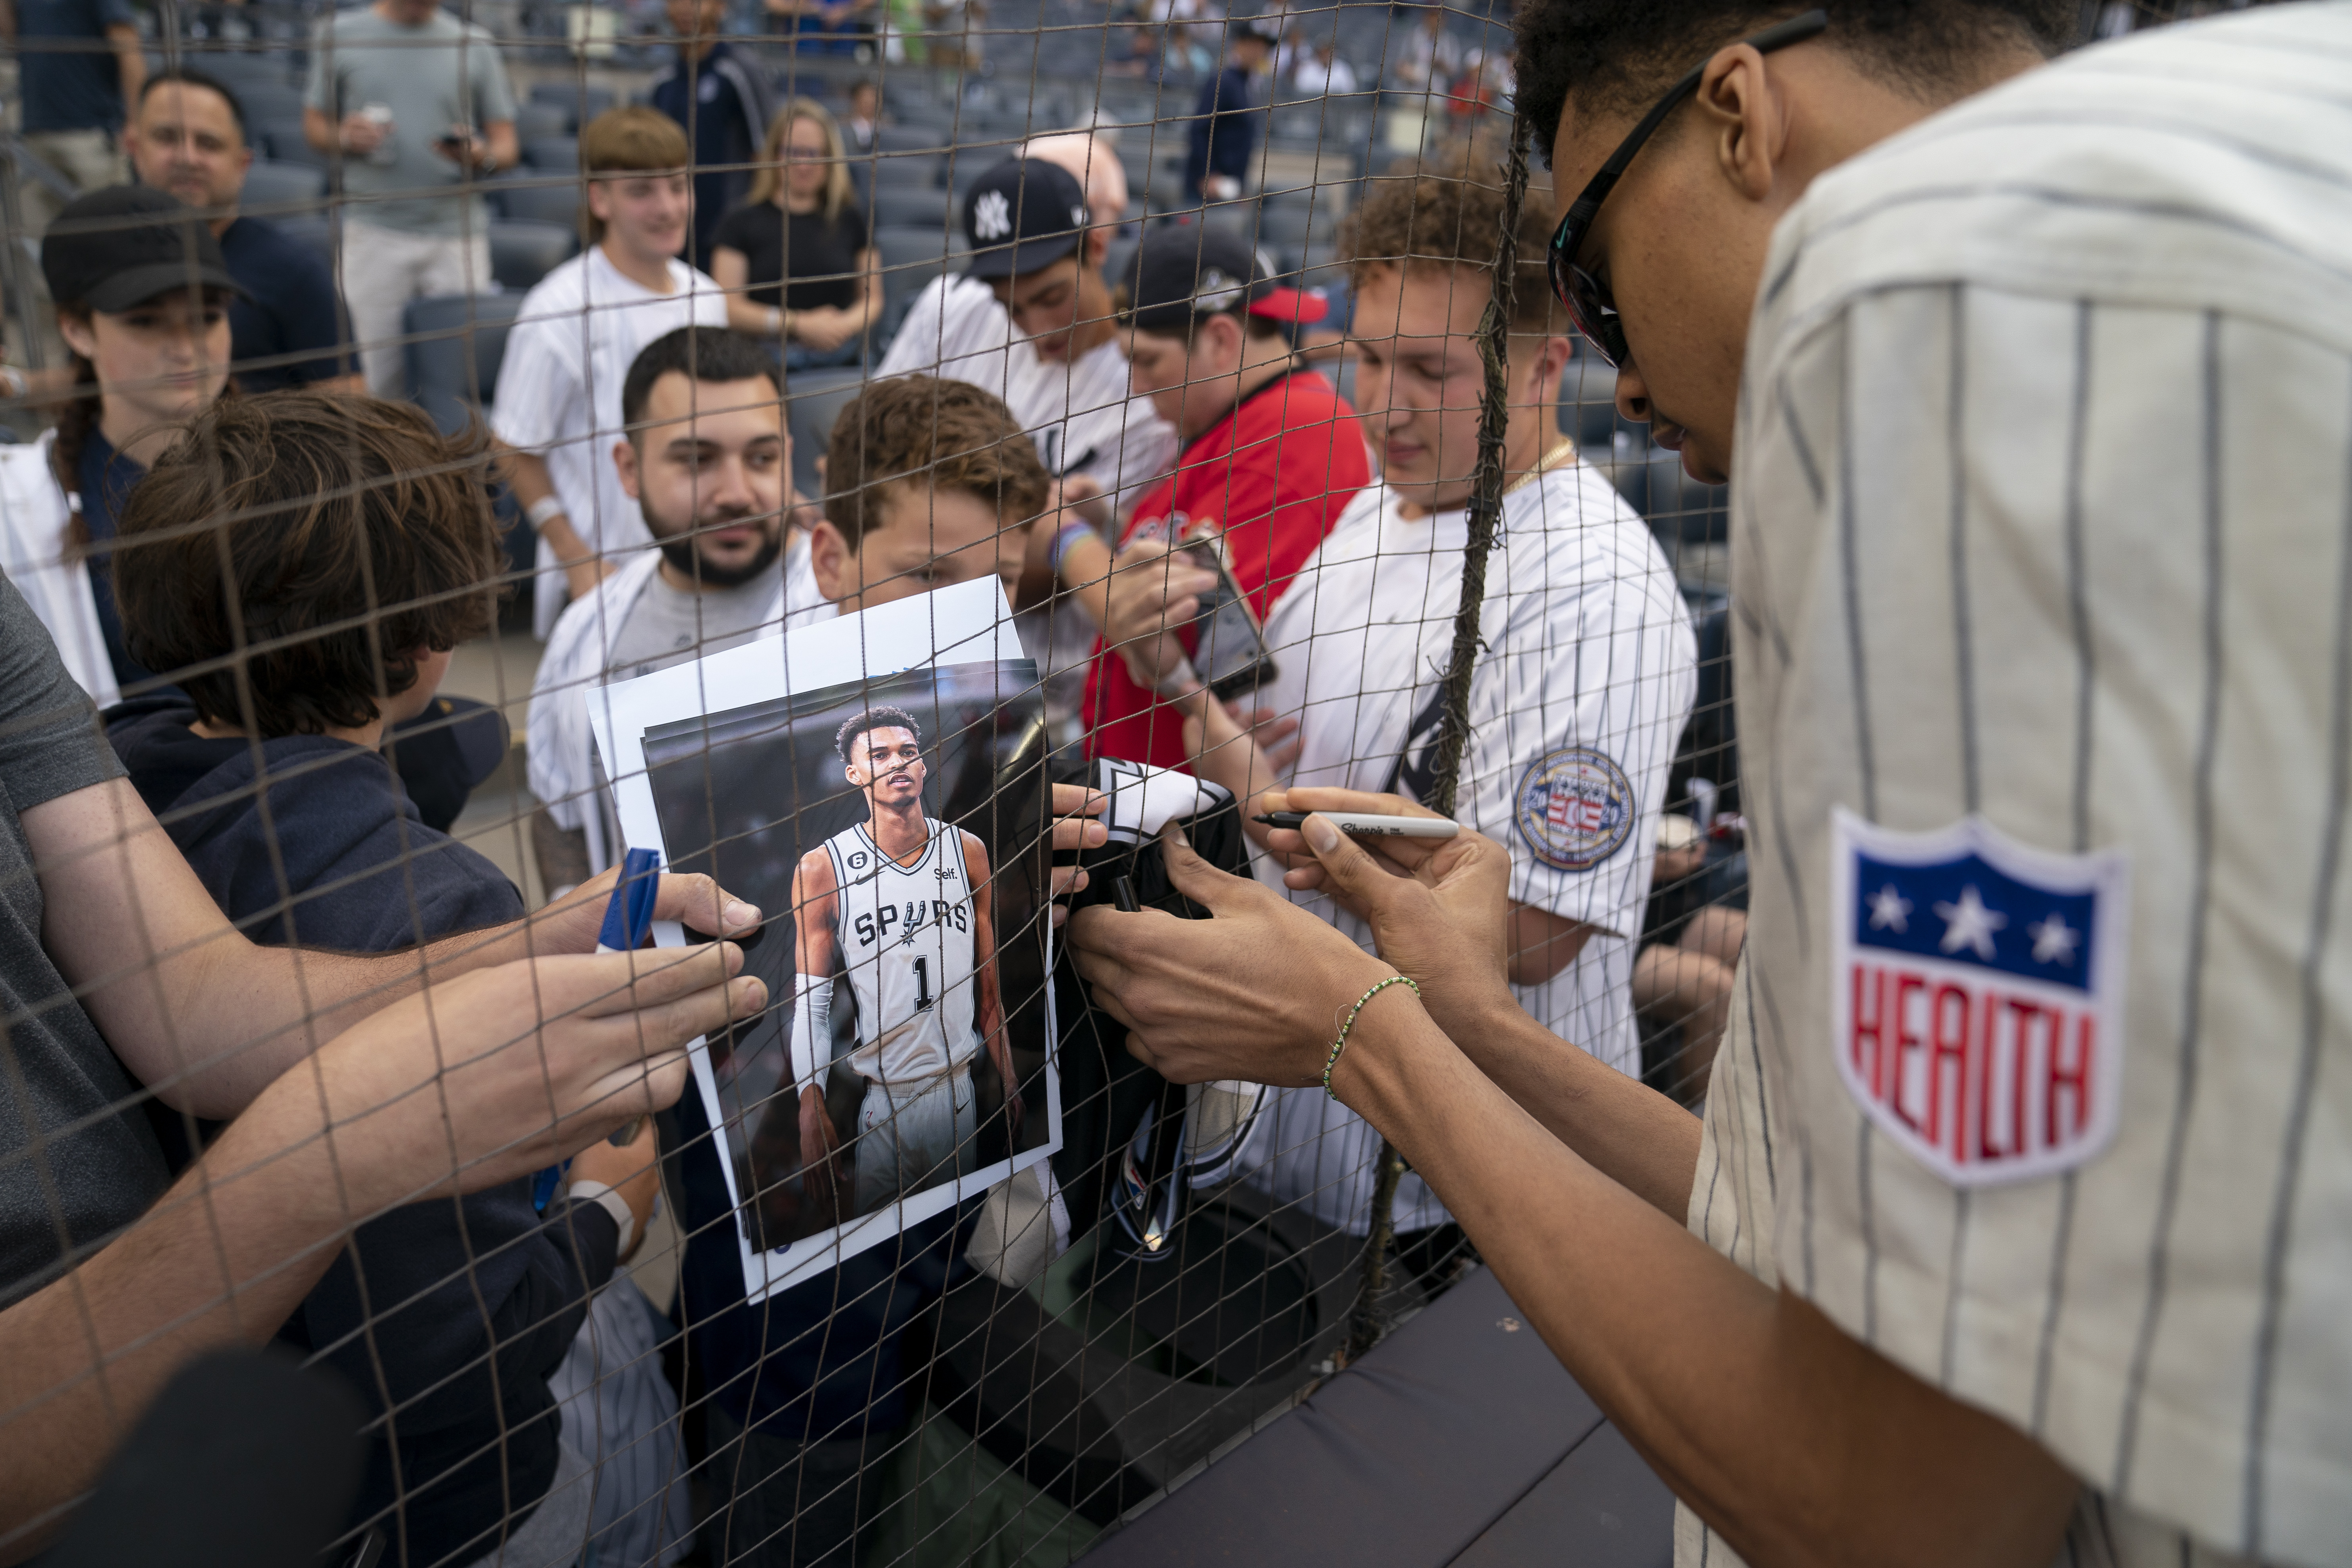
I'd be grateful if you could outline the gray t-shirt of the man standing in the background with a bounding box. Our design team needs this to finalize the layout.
[303,7,515,235]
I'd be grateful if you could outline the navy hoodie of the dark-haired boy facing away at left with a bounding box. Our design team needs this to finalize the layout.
[106,693,618,1563]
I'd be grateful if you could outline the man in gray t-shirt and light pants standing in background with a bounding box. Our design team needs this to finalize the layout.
[303,0,520,397]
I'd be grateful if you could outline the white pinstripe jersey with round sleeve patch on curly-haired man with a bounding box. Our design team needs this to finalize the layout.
[1256,461,1698,1232]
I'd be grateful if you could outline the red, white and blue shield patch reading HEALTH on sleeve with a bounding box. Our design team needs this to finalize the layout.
[1830,811,2131,1187]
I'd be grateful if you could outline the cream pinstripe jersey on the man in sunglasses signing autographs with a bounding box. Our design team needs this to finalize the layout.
[1677,5,2352,1568]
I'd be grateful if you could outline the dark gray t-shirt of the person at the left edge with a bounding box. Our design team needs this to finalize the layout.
[0,578,169,1307]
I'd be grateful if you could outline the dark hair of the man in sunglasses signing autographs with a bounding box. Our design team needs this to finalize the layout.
[1515,0,2082,167]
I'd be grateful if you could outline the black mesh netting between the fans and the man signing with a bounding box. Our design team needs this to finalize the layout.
[0,0,2277,1566]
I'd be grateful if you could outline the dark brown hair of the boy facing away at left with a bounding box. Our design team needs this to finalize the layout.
[113,392,506,738]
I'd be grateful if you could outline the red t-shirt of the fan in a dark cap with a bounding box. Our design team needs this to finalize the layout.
[1084,371,1371,769]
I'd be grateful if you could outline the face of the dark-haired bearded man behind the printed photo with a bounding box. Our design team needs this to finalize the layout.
[614,376,790,588]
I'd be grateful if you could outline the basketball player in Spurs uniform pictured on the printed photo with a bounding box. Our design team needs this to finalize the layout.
[792,708,1021,1218]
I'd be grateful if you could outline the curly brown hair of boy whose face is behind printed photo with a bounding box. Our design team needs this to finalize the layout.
[825,376,1051,550]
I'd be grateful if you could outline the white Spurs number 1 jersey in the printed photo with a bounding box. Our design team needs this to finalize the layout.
[825,820,981,1084]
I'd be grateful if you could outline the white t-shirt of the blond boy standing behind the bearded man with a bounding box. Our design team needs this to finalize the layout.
[489,245,727,637]
